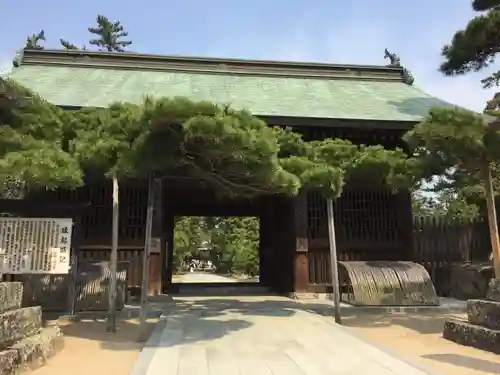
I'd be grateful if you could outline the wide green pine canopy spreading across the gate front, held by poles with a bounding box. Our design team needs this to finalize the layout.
[0,74,414,203]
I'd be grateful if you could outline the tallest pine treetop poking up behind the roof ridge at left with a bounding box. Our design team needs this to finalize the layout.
[88,15,132,52]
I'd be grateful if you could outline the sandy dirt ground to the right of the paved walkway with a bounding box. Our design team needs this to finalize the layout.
[343,313,500,375]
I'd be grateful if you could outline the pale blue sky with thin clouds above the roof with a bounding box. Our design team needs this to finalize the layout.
[0,0,492,110]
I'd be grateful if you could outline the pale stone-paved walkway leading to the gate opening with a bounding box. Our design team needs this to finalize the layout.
[131,297,429,375]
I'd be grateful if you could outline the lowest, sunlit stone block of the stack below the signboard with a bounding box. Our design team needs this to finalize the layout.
[0,327,64,375]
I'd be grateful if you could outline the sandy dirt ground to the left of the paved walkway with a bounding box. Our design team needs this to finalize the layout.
[31,319,156,375]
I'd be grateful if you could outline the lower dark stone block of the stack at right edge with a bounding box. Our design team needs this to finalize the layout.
[443,319,500,354]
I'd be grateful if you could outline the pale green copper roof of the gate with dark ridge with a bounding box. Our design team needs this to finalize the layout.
[9,51,450,121]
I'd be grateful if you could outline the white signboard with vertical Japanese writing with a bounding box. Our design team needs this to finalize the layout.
[0,217,73,274]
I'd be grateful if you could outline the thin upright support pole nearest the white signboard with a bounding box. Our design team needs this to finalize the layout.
[107,176,119,333]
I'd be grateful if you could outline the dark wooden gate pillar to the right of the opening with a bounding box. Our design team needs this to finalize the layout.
[293,191,309,293]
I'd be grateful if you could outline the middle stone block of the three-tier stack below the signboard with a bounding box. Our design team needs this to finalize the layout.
[0,306,42,350]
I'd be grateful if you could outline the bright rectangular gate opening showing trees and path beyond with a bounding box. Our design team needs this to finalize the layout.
[172,216,260,286]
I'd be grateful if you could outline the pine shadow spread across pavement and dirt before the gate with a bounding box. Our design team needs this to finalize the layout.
[56,296,466,350]
